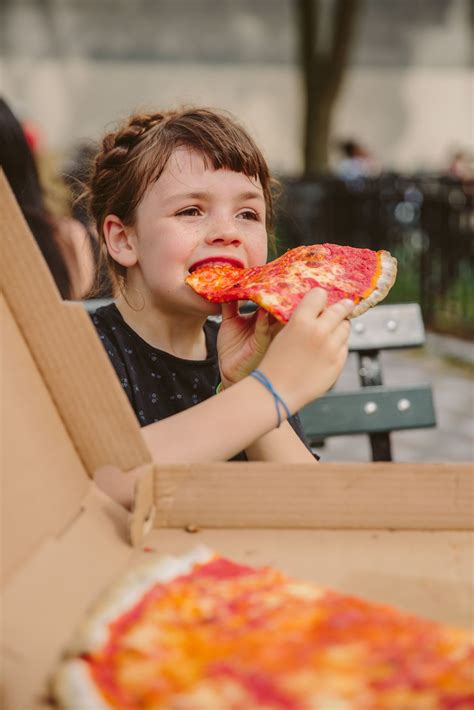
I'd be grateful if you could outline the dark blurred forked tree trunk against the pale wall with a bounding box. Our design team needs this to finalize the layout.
[297,0,359,175]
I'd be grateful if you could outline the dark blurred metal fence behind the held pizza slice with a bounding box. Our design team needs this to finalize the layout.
[276,174,474,337]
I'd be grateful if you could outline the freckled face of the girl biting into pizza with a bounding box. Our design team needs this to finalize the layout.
[127,147,267,315]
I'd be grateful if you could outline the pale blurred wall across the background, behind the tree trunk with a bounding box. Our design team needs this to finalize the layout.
[0,0,474,172]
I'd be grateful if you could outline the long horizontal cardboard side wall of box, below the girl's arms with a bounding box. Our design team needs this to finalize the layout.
[154,462,474,530]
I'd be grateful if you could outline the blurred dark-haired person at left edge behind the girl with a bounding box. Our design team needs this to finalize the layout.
[0,98,95,299]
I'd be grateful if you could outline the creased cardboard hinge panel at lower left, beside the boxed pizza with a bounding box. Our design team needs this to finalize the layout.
[0,485,134,710]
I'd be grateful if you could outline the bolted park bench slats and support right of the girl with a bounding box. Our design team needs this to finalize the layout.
[300,303,436,461]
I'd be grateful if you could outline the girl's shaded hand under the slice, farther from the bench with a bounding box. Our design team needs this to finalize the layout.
[217,303,283,388]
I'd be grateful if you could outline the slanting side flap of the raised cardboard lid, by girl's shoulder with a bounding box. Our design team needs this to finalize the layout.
[0,171,150,476]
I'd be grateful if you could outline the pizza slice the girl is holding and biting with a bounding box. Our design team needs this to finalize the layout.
[185,244,397,323]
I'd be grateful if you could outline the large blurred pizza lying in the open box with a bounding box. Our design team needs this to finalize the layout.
[53,549,474,710]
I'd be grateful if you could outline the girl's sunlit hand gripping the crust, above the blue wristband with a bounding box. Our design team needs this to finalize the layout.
[260,288,354,411]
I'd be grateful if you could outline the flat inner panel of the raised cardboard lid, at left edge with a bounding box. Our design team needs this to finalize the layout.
[0,298,91,578]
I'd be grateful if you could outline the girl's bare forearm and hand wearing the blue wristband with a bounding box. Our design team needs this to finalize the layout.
[142,289,354,463]
